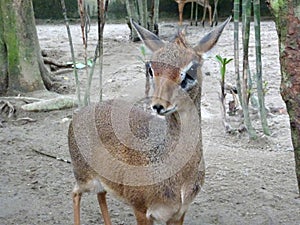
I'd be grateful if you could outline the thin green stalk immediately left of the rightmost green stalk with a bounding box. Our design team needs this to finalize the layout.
[242,0,257,139]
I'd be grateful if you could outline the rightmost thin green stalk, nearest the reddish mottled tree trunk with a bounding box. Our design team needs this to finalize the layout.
[253,0,270,135]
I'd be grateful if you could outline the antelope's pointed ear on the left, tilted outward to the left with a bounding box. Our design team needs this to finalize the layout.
[130,19,165,52]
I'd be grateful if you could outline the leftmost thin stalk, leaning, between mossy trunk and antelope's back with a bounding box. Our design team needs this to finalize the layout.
[60,0,82,107]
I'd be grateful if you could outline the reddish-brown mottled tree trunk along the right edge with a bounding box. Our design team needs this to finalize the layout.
[268,0,300,194]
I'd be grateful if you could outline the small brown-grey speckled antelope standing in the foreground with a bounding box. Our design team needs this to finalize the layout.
[68,18,230,225]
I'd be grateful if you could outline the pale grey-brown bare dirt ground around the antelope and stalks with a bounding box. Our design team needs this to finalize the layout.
[0,22,300,225]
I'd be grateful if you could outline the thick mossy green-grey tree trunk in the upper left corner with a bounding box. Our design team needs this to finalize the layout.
[0,0,51,94]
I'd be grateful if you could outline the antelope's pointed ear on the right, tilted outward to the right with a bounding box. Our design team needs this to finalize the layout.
[194,16,231,55]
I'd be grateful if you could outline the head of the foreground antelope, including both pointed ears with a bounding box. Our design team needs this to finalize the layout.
[131,18,231,115]
